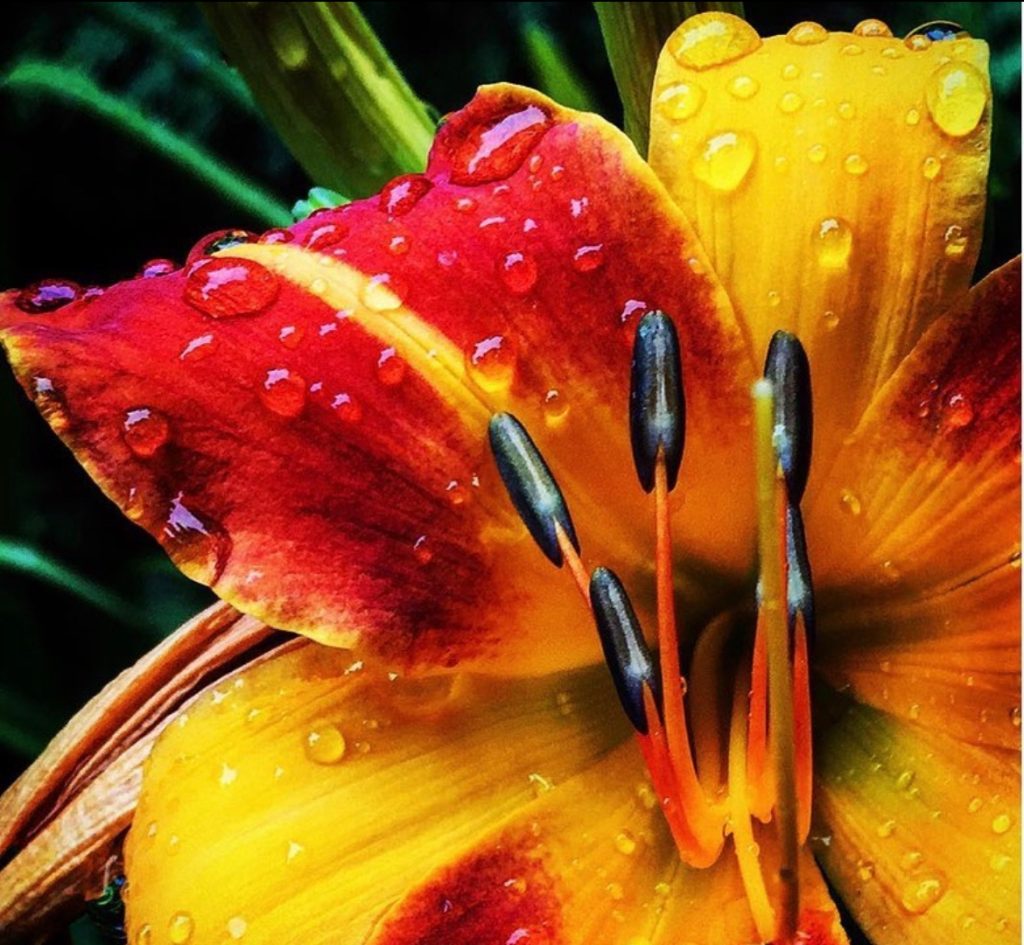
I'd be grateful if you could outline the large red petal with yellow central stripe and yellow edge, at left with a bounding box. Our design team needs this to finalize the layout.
[0,86,752,672]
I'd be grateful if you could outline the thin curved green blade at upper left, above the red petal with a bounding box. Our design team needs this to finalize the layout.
[3,59,292,226]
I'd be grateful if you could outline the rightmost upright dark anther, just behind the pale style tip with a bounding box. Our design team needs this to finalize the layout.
[765,332,813,505]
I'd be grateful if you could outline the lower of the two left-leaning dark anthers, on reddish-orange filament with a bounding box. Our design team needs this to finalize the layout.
[590,567,660,735]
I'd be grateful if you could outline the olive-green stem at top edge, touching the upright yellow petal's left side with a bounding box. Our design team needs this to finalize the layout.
[594,3,743,155]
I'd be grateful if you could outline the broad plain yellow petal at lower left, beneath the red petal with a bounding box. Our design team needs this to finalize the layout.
[125,644,626,945]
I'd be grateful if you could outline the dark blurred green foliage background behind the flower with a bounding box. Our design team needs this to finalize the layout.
[0,3,1020,937]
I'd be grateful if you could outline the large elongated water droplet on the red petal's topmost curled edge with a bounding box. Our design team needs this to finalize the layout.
[442,104,551,184]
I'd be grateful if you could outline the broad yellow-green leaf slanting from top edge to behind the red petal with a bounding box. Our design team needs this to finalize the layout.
[203,3,434,197]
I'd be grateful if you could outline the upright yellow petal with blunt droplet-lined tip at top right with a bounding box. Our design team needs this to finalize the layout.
[650,13,990,443]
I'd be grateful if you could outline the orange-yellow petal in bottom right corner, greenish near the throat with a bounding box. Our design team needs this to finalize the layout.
[815,705,1020,945]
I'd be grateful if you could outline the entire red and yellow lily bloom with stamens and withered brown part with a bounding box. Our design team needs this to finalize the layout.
[0,13,1020,945]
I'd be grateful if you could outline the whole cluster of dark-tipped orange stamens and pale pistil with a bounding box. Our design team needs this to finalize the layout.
[489,312,814,942]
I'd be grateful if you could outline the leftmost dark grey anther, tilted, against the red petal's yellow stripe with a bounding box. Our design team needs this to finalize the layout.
[488,414,580,567]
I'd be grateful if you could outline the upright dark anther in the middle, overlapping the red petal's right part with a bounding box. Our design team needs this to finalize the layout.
[630,311,686,492]
